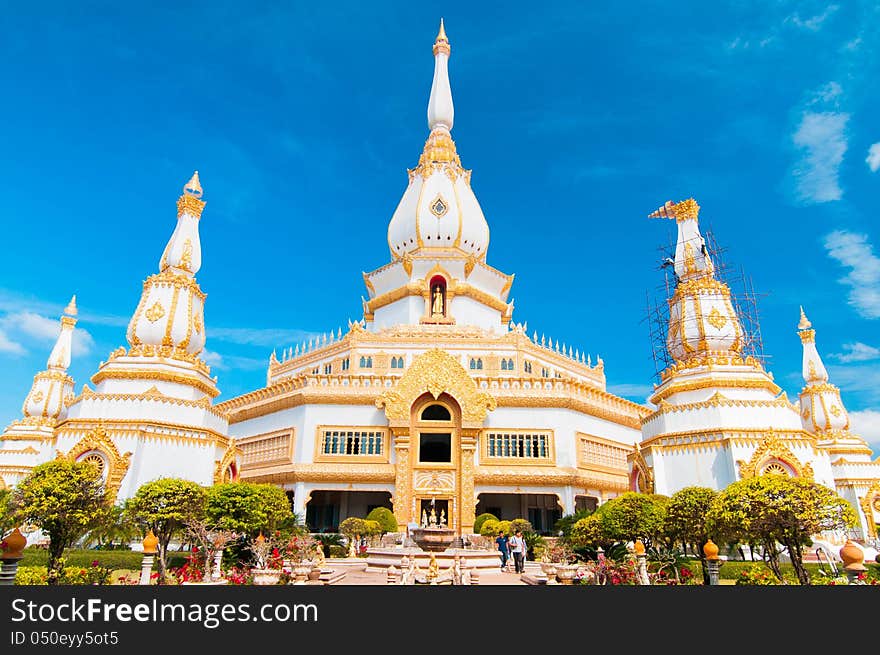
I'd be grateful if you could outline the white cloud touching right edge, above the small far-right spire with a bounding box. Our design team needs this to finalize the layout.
[824,230,880,318]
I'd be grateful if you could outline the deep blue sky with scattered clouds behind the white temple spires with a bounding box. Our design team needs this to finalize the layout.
[0,2,880,450]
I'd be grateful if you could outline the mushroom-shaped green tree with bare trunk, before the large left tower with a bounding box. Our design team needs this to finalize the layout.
[125,478,206,584]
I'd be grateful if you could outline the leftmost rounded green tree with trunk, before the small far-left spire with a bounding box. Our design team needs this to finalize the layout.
[13,459,107,584]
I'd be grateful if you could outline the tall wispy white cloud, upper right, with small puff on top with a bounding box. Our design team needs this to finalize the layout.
[792,110,849,203]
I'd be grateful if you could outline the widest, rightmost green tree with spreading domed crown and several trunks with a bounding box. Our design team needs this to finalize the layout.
[708,475,856,584]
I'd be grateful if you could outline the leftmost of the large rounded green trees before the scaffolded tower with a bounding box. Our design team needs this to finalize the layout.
[596,491,669,548]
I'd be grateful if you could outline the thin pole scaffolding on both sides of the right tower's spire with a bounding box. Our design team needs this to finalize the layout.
[643,228,768,384]
